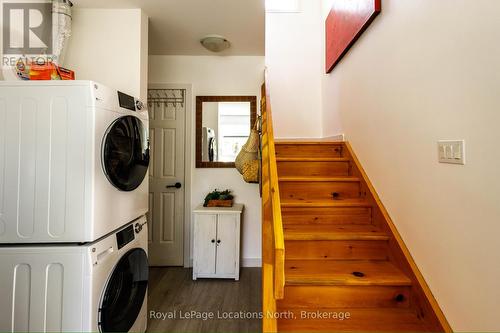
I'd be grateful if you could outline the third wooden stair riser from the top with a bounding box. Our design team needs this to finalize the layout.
[279,181,360,201]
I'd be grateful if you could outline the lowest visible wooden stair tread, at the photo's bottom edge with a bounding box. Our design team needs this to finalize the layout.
[278,307,433,332]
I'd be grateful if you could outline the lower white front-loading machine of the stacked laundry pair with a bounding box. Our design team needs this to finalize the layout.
[0,217,148,332]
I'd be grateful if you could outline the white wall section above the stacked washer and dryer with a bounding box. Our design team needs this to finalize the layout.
[64,8,148,100]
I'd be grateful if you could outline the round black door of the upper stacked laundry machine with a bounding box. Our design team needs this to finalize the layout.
[102,116,149,191]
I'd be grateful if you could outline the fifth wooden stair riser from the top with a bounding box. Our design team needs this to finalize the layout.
[285,240,388,260]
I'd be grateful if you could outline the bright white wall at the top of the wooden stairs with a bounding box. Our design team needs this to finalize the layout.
[266,0,324,138]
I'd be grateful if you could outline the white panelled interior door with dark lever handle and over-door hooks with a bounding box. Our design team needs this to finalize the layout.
[148,89,186,266]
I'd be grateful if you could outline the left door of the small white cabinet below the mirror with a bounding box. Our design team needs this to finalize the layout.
[193,214,217,274]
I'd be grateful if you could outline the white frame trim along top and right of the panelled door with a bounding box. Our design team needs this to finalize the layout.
[148,83,193,268]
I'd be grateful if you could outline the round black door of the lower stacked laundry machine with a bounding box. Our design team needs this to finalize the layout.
[99,248,148,332]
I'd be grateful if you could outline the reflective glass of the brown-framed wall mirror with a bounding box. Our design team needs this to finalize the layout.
[201,102,251,162]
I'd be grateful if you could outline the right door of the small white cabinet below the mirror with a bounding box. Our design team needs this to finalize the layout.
[217,214,240,275]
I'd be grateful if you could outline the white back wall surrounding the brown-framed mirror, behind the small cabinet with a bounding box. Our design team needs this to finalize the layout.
[149,56,264,266]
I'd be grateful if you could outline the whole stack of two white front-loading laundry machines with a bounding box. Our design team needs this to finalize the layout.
[0,81,150,332]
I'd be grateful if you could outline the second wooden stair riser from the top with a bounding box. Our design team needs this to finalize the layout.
[278,161,349,177]
